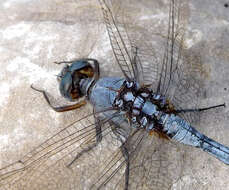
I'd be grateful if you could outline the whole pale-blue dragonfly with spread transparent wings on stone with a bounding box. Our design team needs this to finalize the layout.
[0,0,229,189]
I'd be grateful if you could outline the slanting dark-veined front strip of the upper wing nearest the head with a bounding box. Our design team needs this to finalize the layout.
[99,0,145,82]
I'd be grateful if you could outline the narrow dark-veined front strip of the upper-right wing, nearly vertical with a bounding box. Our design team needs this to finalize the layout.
[157,0,187,95]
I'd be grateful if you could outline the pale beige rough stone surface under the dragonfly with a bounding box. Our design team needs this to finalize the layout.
[0,0,229,190]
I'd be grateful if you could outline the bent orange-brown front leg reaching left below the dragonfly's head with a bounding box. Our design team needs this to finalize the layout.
[31,85,86,112]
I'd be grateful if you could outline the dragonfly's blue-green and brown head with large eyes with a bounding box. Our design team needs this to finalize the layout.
[57,60,94,101]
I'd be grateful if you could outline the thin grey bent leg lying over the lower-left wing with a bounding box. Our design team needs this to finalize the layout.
[67,115,103,167]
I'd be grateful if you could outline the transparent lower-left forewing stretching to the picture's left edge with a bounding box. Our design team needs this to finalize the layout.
[0,109,120,189]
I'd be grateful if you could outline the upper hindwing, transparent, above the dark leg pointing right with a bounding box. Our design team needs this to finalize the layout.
[141,0,207,123]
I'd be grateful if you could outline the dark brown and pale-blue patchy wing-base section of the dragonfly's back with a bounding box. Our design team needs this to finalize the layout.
[113,81,165,130]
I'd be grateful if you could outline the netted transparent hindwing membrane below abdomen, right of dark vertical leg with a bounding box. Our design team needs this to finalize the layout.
[129,131,186,190]
